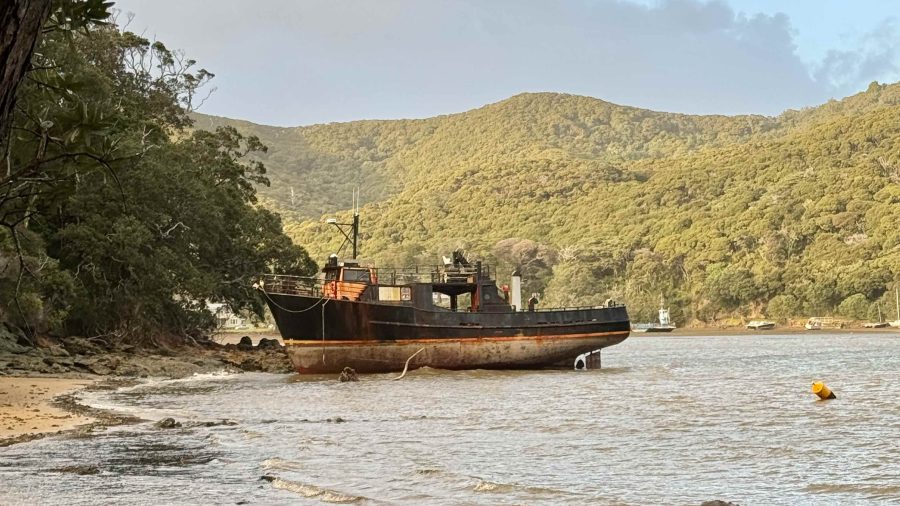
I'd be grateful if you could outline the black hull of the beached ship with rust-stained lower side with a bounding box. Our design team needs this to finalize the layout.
[267,293,630,374]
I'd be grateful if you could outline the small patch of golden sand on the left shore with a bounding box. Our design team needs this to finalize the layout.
[0,376,94,445]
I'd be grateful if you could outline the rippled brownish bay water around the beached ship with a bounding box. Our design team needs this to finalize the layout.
[0,334,900,505]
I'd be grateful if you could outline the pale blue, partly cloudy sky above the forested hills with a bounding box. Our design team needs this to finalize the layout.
[109,0,900,126]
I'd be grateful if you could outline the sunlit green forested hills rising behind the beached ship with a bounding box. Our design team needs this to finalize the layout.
[196,83,900,323]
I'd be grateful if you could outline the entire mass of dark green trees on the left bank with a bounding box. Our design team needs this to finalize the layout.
[0,17,316,342]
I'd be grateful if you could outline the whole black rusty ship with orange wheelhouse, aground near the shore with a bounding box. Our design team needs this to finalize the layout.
[257,209,630,373]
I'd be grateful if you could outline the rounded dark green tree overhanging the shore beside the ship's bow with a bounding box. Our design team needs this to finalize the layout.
[50,128,315,339]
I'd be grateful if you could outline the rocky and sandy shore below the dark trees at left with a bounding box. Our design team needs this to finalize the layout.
[0,335,293,448]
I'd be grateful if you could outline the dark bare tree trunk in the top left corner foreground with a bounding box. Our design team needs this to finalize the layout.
[0,0,50,144]
